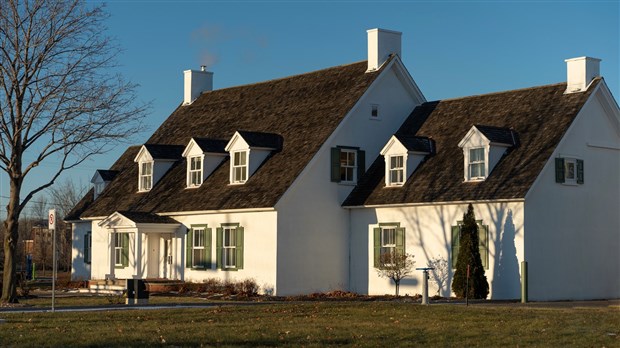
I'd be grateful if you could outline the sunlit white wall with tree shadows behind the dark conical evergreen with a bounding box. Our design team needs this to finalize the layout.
[350,201,524,299]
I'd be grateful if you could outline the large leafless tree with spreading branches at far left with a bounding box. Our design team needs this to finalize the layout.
[0,0,146,302]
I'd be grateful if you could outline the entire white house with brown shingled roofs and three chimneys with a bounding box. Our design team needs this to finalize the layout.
[66,29,620,300]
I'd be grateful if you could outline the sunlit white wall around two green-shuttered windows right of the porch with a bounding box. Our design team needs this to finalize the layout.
[168,211,278,292]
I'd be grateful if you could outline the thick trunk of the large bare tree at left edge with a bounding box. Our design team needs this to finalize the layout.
[0,178,21,303]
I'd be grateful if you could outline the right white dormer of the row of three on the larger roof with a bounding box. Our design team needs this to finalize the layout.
[225,131,283,184]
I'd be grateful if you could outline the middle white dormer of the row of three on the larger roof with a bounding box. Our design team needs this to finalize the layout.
[182,138,228,188]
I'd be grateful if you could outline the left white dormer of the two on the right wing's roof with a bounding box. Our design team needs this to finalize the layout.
[381,135,435,187]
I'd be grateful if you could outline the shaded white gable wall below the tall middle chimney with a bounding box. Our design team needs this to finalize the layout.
[276,64,419,295]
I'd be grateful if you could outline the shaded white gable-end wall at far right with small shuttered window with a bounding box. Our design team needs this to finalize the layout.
[525,84,620,300]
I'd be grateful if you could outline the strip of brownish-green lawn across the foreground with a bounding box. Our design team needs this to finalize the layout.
[0,302,620,347]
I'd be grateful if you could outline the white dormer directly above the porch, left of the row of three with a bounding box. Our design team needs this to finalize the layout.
[134,144,184,192]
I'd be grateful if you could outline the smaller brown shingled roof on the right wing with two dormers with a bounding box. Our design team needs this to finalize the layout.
[343,78,600,206]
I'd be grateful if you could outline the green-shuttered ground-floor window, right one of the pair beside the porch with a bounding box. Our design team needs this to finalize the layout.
[217,224,244,271]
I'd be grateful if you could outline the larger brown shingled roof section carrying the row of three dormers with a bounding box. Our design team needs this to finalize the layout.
[72,61,387,218]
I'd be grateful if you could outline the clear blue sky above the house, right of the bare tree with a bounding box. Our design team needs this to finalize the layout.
[6,0,620,218]
